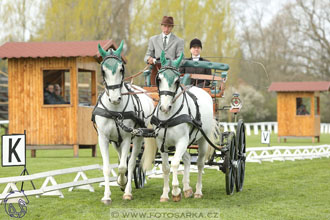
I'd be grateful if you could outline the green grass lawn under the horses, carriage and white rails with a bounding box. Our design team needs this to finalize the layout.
[0,131,330,220]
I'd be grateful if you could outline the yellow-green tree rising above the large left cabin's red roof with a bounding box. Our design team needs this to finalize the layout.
[38,0,131,44]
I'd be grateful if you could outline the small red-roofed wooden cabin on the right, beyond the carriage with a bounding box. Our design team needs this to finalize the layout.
[268,82,330,142]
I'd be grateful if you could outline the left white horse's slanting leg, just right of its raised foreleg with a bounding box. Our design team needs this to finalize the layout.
[123,137,143,200]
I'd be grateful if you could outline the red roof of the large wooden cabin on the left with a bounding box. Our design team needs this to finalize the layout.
[0,40,117,59]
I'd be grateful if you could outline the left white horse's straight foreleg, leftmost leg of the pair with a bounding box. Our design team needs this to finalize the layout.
[98,133,111,205]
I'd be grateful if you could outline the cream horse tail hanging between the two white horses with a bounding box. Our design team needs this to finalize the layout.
[141,124,157,171]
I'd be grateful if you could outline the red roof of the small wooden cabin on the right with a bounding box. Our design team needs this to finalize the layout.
[268,81,330,92]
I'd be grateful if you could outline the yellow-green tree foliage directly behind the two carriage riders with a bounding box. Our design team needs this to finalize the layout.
[128,0,240,84]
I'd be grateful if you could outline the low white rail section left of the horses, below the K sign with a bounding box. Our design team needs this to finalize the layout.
[0,164,118,203]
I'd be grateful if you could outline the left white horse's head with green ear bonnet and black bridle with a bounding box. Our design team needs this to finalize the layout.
[98,41,125,105]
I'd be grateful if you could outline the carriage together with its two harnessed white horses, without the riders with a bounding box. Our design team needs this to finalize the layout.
[93,42,245,204]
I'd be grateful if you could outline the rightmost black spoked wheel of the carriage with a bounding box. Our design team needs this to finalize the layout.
[235,119,246,192]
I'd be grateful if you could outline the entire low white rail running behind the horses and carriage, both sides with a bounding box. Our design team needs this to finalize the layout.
[0,145,330,199]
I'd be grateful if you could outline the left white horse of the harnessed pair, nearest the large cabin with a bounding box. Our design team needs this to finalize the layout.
[93,41,154,204]
